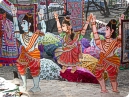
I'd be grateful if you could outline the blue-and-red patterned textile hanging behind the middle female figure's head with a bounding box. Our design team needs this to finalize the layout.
[65,0,84,31]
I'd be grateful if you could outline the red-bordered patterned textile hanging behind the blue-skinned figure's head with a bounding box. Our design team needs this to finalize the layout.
[14,4,37,32]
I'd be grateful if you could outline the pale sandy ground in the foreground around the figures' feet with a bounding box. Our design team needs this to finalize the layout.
[6,70,129,97]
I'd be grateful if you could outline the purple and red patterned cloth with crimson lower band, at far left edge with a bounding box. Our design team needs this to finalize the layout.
[0,19,18,66]
